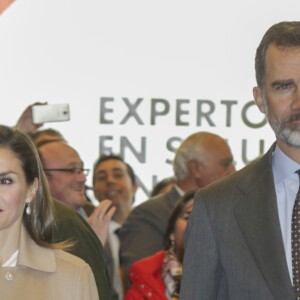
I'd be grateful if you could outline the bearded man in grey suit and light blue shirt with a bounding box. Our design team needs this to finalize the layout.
[180,22,300,300]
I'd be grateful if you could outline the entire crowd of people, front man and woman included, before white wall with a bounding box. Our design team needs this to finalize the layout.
[0,22,300,300]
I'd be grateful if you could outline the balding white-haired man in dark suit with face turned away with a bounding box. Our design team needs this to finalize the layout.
[119,132,235,287]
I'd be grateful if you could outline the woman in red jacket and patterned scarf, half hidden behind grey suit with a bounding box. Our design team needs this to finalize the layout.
[125,191,195,300]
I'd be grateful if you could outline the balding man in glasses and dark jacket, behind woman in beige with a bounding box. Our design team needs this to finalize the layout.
[36,138,111,299]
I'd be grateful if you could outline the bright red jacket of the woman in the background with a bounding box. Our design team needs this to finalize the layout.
[125,251,168,300]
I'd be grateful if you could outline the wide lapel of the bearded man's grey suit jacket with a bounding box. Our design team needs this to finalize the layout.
[235,146,294,299]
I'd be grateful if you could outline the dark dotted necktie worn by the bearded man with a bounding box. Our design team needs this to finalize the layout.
[292,170,300,300]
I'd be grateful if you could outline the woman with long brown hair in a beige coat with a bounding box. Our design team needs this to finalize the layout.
[0,125,99,300]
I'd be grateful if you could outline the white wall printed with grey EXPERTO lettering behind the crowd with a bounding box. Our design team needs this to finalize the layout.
[0,0,300,203]
